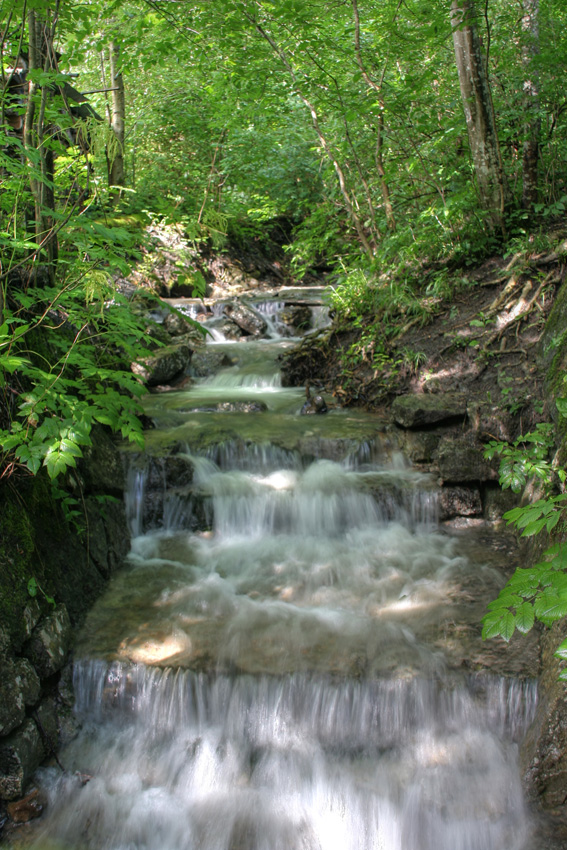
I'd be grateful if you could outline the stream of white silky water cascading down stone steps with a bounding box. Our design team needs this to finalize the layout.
[32,304,536,850]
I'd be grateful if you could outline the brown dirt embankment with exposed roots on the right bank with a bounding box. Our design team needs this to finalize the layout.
[284,240,567,439]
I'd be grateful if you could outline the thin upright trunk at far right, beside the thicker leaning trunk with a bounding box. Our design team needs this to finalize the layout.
[522,0,541,210]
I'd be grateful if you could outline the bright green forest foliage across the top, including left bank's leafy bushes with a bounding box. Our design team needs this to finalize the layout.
[0,0,567,477]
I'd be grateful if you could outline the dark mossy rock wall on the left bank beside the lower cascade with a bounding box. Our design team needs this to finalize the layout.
[0,428,129,824]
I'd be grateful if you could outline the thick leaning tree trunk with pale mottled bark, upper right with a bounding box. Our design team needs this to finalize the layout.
[451,0,507,230]
